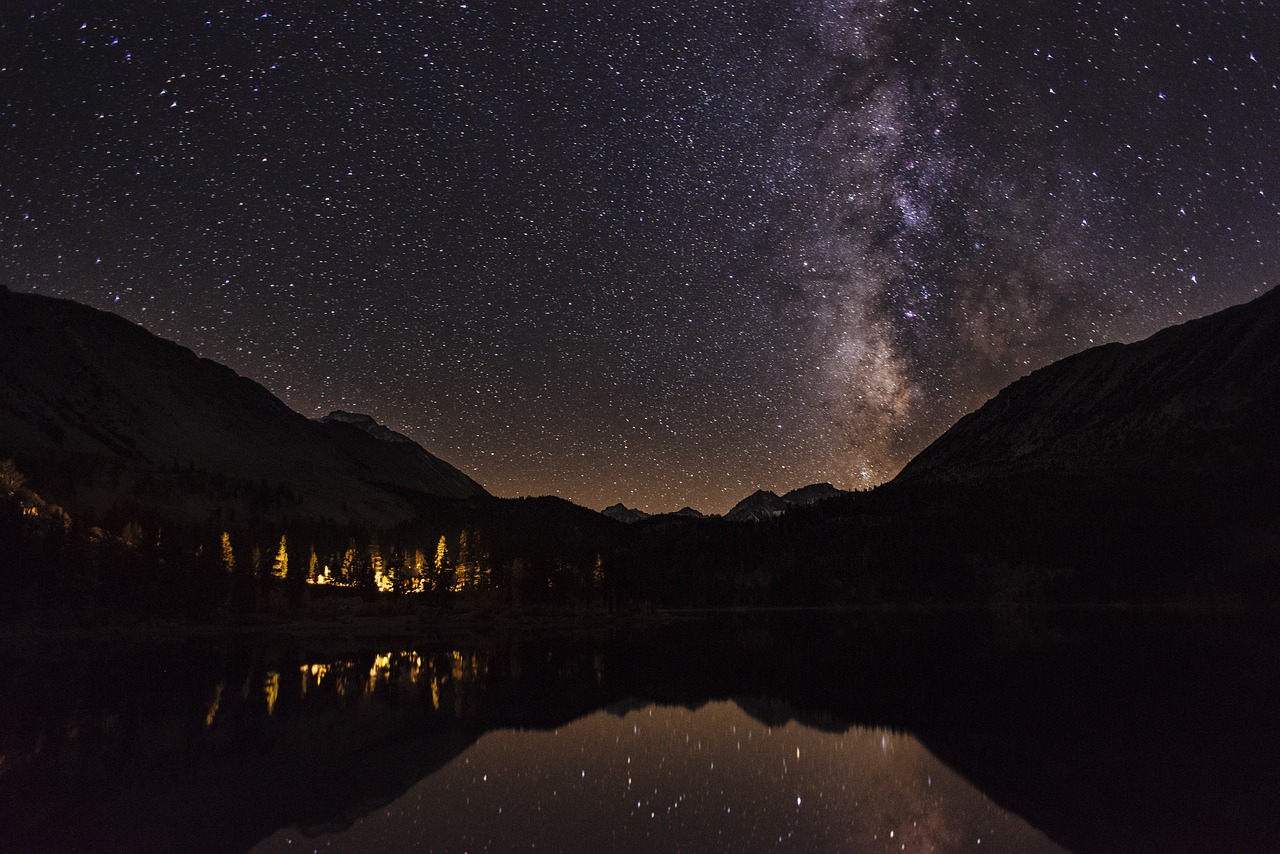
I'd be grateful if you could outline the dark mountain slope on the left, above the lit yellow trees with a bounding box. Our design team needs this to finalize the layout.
[0,289,486,524]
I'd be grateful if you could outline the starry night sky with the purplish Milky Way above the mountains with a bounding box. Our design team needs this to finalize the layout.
[0,0,1280,512]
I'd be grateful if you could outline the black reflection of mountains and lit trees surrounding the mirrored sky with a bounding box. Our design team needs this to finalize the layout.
[0,612,1280,851]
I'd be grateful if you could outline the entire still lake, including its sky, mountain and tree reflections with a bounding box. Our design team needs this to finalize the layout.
[0,612,1280,851]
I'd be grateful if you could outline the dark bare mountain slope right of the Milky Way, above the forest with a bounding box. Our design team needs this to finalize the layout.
[893,288,1280,484]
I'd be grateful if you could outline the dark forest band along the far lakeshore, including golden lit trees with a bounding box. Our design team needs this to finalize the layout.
[0,453,1280,618]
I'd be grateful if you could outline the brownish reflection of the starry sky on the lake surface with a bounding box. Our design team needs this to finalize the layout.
[253,700,1062,854]
